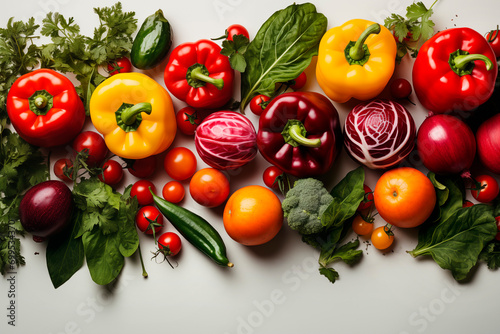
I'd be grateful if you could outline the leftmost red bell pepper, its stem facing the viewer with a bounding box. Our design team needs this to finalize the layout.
[7,69,85,147]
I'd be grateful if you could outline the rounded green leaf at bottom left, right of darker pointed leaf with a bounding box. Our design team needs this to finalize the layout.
[82,230,125,285]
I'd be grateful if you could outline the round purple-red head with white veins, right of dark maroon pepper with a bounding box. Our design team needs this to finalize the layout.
[344,99,416,169]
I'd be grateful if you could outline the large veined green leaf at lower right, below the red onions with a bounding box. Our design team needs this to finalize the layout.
[408,204,497,280]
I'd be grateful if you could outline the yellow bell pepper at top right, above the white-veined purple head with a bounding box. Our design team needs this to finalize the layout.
[316,19,397,103]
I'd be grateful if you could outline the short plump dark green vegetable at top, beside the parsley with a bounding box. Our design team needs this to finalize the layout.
[130,9,172,70]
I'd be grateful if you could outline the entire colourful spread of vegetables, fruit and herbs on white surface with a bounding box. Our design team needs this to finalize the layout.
[0,0,500,288]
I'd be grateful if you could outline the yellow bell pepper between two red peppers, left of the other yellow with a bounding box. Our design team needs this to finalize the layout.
[89,73,177,159]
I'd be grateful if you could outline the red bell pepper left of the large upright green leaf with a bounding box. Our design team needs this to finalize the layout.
[164,39,234,109]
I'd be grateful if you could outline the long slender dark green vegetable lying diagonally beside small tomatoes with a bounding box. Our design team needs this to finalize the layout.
[150,189,233,267]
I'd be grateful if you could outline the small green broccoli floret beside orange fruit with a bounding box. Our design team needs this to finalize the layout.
[282,178,333,234]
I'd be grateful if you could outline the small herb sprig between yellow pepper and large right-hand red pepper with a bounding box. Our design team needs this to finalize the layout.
[384,0,437,62]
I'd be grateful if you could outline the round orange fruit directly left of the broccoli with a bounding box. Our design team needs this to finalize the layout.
[223,185,283,246]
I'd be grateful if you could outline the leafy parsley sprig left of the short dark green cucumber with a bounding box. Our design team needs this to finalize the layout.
[41,2,137,115]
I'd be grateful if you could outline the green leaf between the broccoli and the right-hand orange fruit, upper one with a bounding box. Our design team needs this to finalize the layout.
[321,167,365,227]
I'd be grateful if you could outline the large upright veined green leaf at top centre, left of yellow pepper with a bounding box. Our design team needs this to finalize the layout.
[240,3,327,111]
